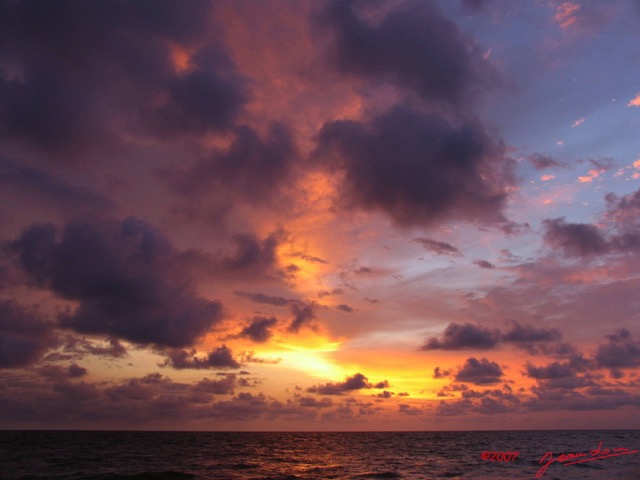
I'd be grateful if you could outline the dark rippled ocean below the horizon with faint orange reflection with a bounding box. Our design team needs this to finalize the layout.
[0,430,640,480]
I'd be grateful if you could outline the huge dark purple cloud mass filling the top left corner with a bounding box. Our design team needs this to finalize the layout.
[0,0,248,160]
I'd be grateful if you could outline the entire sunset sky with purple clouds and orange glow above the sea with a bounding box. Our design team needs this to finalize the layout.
[0,0,640,431]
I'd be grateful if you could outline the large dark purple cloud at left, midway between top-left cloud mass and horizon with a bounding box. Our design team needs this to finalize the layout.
[11,218,225,347]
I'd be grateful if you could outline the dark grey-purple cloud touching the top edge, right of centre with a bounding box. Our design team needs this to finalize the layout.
[323,0,494,104]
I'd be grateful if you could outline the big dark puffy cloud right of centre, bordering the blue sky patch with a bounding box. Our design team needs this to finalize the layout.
[316,105,513,225]
